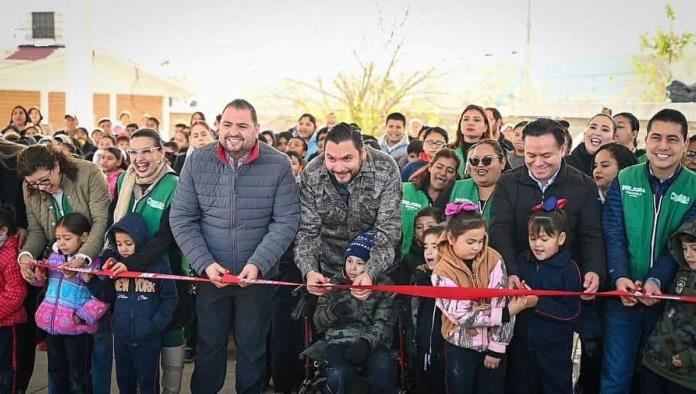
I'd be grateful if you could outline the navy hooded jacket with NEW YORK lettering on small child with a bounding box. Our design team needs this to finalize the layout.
[88,213,178,343]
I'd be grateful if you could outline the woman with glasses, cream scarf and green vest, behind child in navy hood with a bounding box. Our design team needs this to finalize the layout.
[111,129,191,393]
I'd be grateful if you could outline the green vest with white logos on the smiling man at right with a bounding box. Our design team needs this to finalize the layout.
[619,163,696,281]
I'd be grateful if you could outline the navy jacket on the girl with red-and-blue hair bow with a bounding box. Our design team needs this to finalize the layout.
[513,249,582,350]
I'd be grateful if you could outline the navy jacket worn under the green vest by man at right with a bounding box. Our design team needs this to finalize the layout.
[602,166,696,291]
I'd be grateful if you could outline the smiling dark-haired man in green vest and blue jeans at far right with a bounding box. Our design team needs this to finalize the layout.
[601,109,696,393]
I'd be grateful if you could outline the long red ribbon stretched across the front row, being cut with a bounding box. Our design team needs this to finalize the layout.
[28,263,696,303]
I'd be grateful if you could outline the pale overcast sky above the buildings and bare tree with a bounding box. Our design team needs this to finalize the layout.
[0,0,696,115]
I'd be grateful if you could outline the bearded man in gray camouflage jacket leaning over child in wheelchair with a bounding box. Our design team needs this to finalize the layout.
[295,123,402,299]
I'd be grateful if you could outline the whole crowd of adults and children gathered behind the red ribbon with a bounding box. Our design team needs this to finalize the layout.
[0,99,696,394]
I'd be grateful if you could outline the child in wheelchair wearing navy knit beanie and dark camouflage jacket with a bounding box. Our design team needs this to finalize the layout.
[314,231,396,394]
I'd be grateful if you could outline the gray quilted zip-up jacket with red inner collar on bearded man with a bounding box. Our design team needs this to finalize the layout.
[169,142,300,276]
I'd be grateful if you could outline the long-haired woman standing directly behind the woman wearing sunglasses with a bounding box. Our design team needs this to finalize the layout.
[452,104,491,178]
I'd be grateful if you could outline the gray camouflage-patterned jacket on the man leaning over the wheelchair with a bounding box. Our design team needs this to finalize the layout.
[295,148,403,279]
